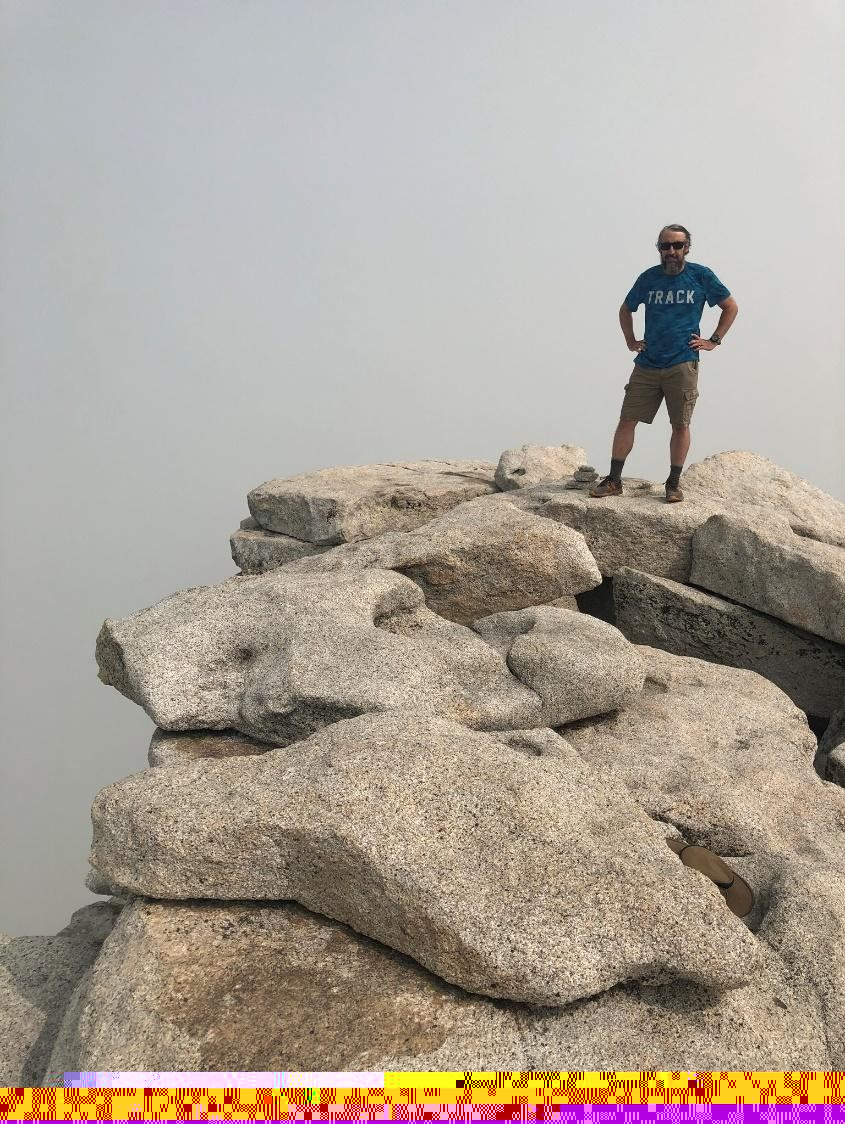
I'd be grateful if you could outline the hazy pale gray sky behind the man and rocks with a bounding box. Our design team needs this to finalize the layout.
[0,0,845,935]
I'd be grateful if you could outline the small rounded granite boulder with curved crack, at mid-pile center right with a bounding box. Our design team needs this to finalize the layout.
[473,605,645,726]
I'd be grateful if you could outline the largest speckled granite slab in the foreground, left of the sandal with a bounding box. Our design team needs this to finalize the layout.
[91,713,764,1006]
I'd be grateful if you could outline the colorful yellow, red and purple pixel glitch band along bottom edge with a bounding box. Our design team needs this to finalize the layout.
[0,1071,845,1124]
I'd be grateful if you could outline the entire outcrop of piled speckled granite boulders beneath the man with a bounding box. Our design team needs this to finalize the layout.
[0,445,845,1086]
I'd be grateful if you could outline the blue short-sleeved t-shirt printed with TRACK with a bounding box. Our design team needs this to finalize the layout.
[625,262,730,369]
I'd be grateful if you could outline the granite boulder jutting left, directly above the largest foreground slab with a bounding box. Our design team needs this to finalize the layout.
[97,568,542,745]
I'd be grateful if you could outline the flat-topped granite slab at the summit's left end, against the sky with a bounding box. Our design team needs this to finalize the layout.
[247,460,497,545]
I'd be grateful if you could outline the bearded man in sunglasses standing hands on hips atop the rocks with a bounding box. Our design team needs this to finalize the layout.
[590,224,739,504]
